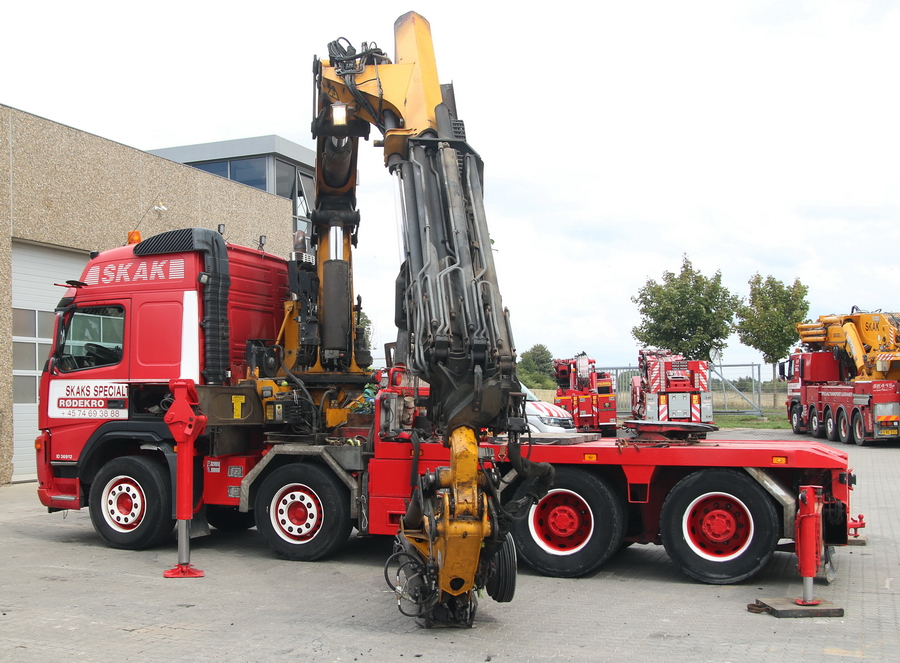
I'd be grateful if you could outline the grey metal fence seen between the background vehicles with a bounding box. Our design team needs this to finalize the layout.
[534,362,787,417]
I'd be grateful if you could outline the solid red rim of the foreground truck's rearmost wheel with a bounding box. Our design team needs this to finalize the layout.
[682,493,753,562]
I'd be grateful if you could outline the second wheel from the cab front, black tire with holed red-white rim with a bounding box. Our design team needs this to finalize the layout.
[255,463,352,562]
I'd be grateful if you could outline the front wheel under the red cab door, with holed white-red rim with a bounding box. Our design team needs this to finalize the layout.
[88,456,175,550]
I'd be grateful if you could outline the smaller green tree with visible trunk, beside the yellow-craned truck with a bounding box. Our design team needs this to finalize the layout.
[737,272,809,406]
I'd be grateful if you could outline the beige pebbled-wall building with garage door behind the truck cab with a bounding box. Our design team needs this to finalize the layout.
[0,105,311,484]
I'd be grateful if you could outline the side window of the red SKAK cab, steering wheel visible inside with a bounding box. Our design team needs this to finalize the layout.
[59,306,125,372]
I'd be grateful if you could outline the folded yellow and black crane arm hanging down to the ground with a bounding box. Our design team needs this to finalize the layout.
[312,12,553,624]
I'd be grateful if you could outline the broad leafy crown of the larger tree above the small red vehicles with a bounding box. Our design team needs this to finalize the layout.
[631,254,740,359]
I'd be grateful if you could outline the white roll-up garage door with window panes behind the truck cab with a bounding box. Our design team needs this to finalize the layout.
[12,242,88,481]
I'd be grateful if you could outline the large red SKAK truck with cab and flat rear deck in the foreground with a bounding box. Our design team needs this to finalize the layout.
[36,229,862,583]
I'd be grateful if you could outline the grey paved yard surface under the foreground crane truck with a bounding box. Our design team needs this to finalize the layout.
[0,430,900,663]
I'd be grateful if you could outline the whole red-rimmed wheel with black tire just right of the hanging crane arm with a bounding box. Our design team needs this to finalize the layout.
[513,466,626,578]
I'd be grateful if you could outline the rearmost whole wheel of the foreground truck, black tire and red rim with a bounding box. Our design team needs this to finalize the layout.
[659,470,781,585]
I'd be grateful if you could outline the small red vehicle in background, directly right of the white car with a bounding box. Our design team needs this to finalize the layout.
[553,353,616,437]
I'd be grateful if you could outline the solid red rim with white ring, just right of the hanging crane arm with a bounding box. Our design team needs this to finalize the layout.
[528,489,594,555]
